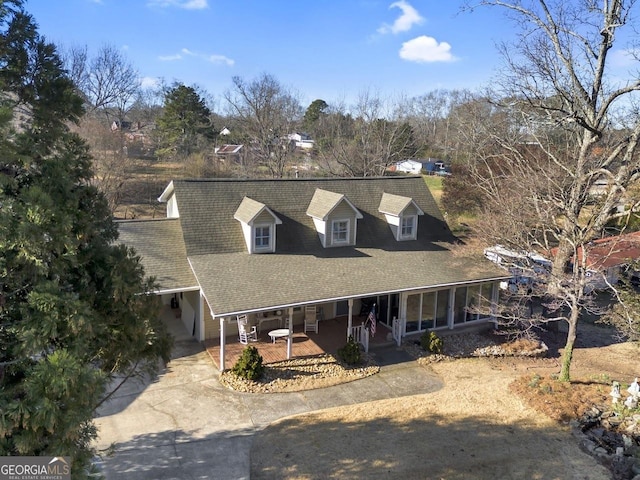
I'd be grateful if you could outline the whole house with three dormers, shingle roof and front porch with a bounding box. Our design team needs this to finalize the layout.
[118,176,508,368]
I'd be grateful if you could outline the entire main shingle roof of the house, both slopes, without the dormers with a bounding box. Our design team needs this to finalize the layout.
[162,177,504,315]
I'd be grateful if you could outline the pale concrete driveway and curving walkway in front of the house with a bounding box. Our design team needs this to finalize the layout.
[96,316,442,480]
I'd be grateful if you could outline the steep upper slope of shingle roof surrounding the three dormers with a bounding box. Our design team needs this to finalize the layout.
[173,177,454,257]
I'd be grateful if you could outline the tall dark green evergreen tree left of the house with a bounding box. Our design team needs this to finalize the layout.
[0,0,170,478]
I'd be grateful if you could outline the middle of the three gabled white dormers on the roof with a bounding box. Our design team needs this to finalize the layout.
[307,188,362,248]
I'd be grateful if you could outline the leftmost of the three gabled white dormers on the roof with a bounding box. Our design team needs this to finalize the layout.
[233,197,282,253]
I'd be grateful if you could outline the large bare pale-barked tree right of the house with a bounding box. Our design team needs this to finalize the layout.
[462,0,640,381]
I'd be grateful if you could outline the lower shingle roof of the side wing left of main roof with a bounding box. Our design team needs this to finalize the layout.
[117,218,198,290]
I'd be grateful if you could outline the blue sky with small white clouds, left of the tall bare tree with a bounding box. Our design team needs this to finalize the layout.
[25,0,512,106]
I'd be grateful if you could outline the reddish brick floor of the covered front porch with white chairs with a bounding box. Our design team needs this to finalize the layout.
[205,317,391,368]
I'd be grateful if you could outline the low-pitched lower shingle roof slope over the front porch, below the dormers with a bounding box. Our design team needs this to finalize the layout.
[190,244,504,316]
